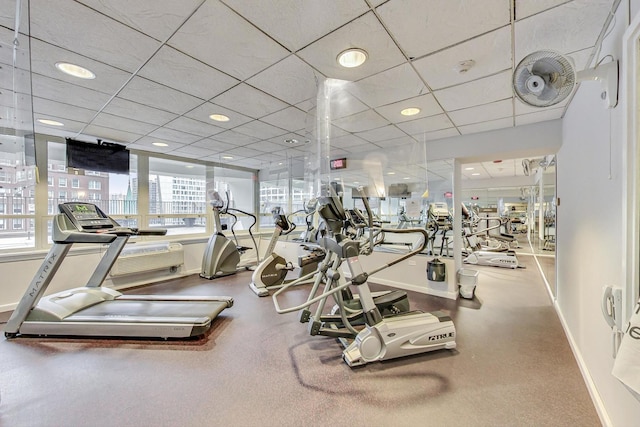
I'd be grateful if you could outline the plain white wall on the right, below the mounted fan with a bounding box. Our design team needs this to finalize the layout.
[556,1,640,426]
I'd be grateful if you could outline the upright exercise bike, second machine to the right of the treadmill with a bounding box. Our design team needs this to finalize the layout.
[249,207,324,297]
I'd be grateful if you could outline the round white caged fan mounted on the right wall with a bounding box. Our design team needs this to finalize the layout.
[513,50,618,108]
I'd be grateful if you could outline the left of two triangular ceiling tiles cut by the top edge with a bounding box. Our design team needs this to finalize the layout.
[78,0,203,41]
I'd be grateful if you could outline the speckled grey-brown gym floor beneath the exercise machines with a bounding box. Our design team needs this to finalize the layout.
[0,256,600,426]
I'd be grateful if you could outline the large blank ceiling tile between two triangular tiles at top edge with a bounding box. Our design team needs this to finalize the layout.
[169,1,289,80]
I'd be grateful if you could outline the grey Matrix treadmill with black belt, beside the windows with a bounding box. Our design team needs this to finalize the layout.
[4,202,233,339]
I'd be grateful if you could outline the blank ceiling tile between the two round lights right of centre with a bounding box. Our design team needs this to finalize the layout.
[348,64,429,107]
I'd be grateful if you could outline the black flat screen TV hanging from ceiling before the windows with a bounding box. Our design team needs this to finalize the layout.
[66,138,129,174]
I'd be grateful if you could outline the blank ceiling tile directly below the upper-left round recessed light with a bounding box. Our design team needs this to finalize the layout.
[31,74,109,110]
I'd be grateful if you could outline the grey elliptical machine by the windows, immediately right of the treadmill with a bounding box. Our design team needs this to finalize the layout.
[200,191,258,279]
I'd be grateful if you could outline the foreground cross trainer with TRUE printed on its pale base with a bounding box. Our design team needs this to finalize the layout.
[272,192,456,366]
